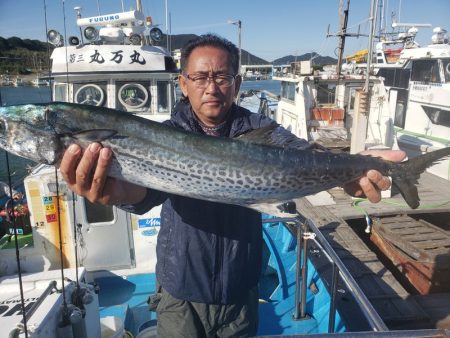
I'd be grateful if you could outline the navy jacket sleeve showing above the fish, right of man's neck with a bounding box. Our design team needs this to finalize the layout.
[250,114,310,149]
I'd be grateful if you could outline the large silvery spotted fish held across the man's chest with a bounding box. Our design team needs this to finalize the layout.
[0,102,450,214]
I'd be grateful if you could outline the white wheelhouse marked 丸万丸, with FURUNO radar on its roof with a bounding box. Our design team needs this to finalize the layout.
[48,6,178,122]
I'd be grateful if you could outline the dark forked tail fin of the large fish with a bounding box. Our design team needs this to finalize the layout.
[391,147,450,209]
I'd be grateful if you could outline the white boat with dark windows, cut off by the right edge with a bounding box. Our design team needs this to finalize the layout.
[376,25,450,180]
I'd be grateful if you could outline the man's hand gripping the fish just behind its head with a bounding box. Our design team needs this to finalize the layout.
[59,143,147,205]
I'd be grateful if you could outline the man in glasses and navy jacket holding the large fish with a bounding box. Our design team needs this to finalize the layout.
[60,34,404,337]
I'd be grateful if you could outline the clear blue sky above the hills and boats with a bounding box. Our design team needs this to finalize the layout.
[0,0,450,61]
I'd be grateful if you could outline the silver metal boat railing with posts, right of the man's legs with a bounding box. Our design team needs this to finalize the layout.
[264,215,389,333]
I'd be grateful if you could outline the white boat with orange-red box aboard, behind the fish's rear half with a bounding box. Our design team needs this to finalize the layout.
[274,61,394,150]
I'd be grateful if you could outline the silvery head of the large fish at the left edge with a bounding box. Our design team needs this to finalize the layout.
[0,104,61,164]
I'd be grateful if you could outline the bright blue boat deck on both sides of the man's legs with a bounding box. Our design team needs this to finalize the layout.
[95,219,345,335]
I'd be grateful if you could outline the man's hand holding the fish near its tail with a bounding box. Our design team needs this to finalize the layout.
[344,150,406,203]
